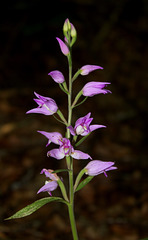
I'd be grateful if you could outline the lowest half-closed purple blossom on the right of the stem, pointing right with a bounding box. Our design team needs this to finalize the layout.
[85,160,117,177]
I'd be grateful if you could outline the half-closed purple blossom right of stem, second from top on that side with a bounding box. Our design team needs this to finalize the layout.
[82,82,111,97]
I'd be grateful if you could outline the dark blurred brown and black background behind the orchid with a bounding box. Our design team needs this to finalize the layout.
[0,0,148,240]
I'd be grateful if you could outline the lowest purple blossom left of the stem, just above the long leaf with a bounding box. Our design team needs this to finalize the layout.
[37,168,59,196]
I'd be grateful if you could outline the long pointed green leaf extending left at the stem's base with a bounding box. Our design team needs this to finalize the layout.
[6,197,67,220]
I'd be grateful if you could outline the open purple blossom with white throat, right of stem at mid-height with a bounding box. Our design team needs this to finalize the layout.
[68,113,106,136]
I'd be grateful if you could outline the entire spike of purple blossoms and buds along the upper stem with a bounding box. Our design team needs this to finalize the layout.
[27,19,116,199]
